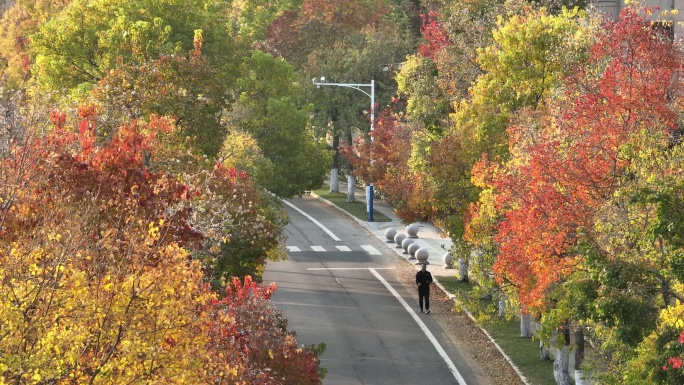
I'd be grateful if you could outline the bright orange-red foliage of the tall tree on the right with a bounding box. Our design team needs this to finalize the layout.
[480,8,682,307]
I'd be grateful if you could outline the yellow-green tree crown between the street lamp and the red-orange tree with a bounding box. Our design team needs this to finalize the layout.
[452,8,588,164]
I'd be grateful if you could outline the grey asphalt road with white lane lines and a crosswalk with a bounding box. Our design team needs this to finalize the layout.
[263,197,484,385]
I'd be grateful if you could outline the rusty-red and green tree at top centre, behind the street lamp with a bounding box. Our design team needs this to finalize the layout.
[267,0,413,182]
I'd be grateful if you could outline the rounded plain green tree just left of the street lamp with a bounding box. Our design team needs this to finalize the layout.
[230,51,330,197]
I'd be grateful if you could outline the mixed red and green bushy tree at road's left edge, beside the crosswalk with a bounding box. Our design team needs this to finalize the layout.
[183,160,288,290]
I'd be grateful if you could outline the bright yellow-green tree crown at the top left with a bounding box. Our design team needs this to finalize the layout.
[31,0,232,89]
